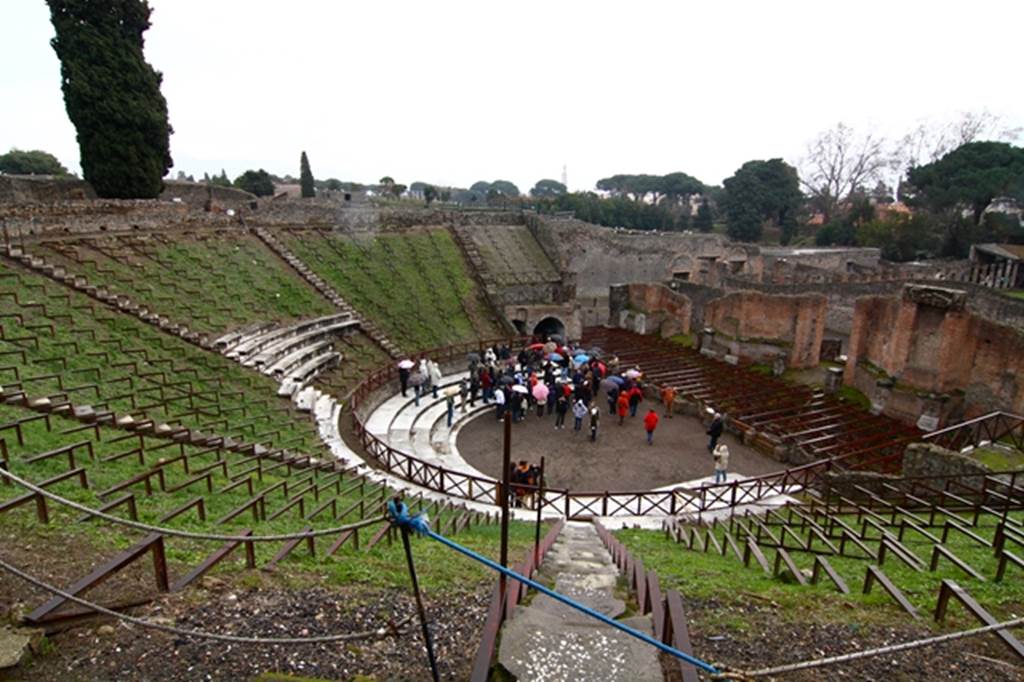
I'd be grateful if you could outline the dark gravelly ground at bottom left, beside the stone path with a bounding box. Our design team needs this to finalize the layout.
[7,579,489,682]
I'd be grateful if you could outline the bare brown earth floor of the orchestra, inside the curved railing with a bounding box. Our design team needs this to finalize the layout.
[457,402,785,492]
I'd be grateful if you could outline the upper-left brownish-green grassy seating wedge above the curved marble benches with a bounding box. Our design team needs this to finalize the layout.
[27,230,333,334]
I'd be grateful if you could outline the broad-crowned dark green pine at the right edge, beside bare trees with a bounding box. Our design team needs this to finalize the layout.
[901,142,1024,225]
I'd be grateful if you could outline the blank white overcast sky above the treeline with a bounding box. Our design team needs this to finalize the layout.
[0,0,1024,191]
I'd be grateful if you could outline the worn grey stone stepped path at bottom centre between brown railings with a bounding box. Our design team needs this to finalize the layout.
[498,522,663,682]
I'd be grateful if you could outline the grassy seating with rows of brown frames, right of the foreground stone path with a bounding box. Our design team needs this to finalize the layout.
[647,475,1024,656]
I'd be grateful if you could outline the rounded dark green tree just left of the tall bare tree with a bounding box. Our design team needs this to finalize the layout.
[724,159,803,242]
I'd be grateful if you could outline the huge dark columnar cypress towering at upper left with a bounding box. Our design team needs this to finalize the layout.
[47,0,173,199]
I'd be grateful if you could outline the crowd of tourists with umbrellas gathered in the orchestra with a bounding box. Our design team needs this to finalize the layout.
[398,337,729,506]
